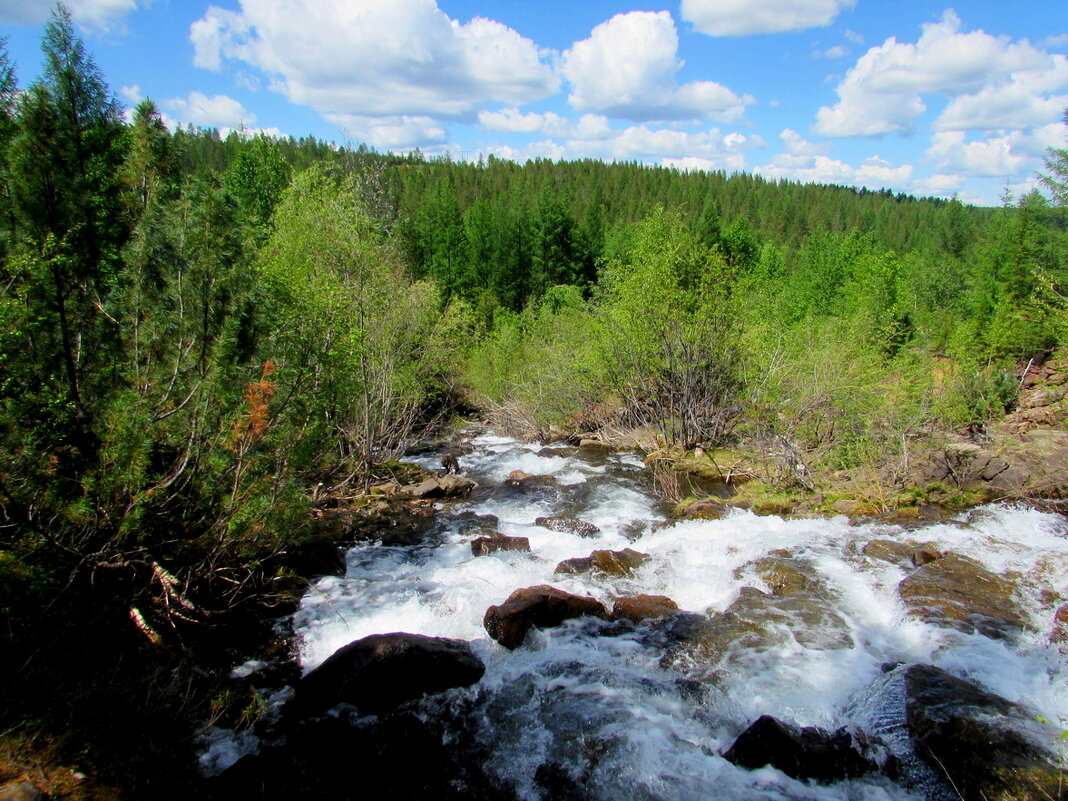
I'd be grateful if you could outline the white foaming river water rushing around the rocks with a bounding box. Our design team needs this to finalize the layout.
[279,433,1068,800]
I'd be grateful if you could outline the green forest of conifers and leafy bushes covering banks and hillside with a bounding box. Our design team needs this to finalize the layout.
[0,10,1068,794]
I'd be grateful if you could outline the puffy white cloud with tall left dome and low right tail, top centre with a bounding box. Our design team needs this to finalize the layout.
[561,11,754,122]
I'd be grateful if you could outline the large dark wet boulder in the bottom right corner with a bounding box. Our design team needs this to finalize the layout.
[905,664,1068,801]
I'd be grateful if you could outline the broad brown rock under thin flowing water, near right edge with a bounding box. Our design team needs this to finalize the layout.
[897,553,1024,640]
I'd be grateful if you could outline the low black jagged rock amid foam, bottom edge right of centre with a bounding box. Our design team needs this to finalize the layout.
[723,714,886,784]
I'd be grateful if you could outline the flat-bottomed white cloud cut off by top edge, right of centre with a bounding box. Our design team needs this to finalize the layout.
[679,0,857,36]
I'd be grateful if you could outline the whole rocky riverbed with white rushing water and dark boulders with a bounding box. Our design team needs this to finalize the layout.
[204,431,1068,801]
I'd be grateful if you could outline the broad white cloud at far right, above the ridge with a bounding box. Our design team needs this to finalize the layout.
[815,11,1064,137]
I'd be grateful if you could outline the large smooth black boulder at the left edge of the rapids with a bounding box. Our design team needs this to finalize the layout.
[285,632,486,718]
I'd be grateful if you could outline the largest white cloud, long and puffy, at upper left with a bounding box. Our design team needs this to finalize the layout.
[190,0,559,117]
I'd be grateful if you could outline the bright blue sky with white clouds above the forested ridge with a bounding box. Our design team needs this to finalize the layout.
[0,0,1068,204]
